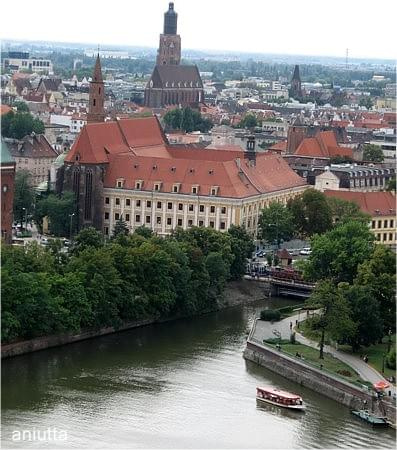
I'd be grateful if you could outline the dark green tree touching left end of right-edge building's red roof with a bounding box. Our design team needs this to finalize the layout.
[288,189,332,236]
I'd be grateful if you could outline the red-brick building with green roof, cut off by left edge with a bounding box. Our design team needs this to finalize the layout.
[0,139,15,244]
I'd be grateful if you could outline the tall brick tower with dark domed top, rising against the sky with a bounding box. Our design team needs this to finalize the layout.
[156,2,181,65]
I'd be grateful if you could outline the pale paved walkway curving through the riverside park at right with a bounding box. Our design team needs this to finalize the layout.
[253,311,396,395]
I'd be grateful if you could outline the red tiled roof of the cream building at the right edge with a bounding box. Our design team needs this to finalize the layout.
[324,190,396,216]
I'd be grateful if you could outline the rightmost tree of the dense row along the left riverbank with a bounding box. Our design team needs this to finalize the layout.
[228,225,255,280]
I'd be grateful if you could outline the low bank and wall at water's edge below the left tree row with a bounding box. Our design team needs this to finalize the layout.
[1,280,267,359]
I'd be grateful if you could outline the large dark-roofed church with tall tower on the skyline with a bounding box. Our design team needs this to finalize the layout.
[145,3,204,108]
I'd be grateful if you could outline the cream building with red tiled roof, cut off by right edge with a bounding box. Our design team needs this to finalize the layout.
[324,190,396,248]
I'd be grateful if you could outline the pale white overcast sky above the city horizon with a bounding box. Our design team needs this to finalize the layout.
[0,0,397,59]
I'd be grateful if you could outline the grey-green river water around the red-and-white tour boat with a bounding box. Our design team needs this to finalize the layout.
[2,299,395,449]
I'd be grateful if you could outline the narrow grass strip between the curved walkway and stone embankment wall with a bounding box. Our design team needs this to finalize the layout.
[268,341,366,384]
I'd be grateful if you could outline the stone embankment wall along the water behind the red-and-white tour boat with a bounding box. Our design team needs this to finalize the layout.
[244,321,396,423]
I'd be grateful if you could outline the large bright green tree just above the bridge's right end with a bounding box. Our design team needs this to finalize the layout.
[304,221,374,283]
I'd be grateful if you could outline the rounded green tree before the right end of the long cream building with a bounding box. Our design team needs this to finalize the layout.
[258,202,295,246]
